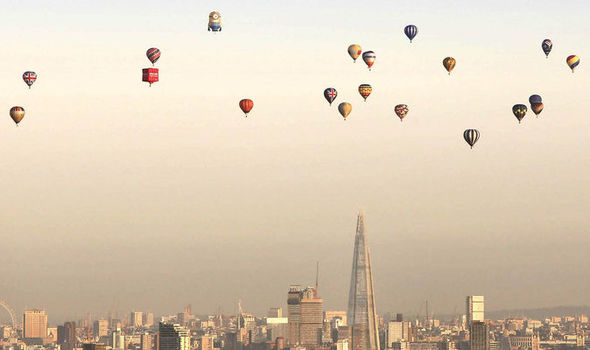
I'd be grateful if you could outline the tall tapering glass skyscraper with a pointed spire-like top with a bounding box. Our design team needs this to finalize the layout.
[347,213,380,350]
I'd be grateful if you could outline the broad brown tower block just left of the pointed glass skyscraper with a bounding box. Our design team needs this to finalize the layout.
[287,286,324,349]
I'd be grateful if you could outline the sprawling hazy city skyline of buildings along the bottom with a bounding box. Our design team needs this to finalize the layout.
[0,213,590,350]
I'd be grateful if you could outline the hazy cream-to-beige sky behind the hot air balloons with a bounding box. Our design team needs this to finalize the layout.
[0,0,590,324]
